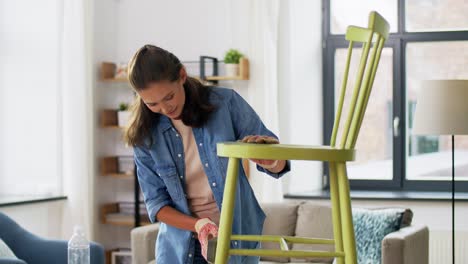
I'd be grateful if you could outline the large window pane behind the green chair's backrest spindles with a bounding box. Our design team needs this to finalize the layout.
[335,48,393,180]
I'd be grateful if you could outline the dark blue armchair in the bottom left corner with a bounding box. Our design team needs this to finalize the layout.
[0,212,104,264]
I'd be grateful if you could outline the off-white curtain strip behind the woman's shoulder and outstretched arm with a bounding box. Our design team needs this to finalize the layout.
[246,0,283,202]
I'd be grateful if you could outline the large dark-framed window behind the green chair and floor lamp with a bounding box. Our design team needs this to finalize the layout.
[322,0,468,191]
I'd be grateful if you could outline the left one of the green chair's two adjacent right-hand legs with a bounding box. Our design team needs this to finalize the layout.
[329,162,344,264]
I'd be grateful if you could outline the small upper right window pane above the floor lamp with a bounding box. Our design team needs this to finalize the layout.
[405,0,468,32]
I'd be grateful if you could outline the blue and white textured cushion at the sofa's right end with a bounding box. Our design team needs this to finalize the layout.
[353,208,412,264]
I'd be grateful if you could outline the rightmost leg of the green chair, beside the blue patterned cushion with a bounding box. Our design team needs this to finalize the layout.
[336,162,357,264]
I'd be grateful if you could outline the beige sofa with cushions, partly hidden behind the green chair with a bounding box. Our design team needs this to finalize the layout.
[131,201,429,264]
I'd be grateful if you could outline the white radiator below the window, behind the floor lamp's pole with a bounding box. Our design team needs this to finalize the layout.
[429,230,468,264]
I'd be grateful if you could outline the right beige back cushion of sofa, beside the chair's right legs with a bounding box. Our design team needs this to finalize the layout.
[291,202,334,263]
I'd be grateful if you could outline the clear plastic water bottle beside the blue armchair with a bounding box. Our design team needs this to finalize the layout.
[68,226,90,264]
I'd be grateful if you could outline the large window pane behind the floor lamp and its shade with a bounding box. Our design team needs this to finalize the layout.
[406,41,468,180]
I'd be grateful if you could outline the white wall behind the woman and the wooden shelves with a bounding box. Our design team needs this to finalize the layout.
[93,0,254,248]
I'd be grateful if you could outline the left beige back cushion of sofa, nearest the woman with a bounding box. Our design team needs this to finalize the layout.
[261,203,299,263]
